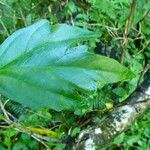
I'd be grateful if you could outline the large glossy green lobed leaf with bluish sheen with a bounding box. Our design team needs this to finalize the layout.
[0,20,132,111]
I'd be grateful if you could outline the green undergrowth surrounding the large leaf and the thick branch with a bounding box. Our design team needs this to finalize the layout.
[0,0,150,150]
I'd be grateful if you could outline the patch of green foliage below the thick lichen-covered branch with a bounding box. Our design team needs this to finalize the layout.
[113,112,150,150]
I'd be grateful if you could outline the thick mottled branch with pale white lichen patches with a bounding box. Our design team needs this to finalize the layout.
[72,79,150,150]
